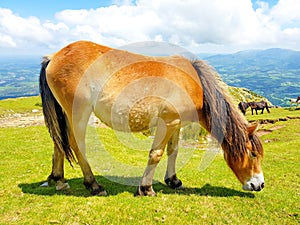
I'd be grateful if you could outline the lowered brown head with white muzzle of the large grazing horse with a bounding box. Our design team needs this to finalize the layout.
[223,126,265,191]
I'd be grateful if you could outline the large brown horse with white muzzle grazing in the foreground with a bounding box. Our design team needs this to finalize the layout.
[40,41,264,196]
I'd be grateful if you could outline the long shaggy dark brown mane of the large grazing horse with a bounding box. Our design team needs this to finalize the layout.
[191,60,262,160]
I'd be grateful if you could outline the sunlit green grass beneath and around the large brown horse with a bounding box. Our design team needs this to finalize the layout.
[0,99,300,224]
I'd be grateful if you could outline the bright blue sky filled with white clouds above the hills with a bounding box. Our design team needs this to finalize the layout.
[0,0,300,55]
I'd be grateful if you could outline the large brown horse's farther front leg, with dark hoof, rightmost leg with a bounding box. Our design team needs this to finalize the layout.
[165,129,183,189]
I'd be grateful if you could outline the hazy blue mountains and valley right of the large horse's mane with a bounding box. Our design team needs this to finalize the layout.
[204,48,300,106]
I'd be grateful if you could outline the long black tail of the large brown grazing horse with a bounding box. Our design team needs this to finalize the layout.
[40,56,76,165]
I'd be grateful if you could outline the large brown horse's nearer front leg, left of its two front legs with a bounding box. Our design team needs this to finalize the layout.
[136,120,179,196]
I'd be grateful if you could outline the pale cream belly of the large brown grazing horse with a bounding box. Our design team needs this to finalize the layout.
[95,92,199,132]
